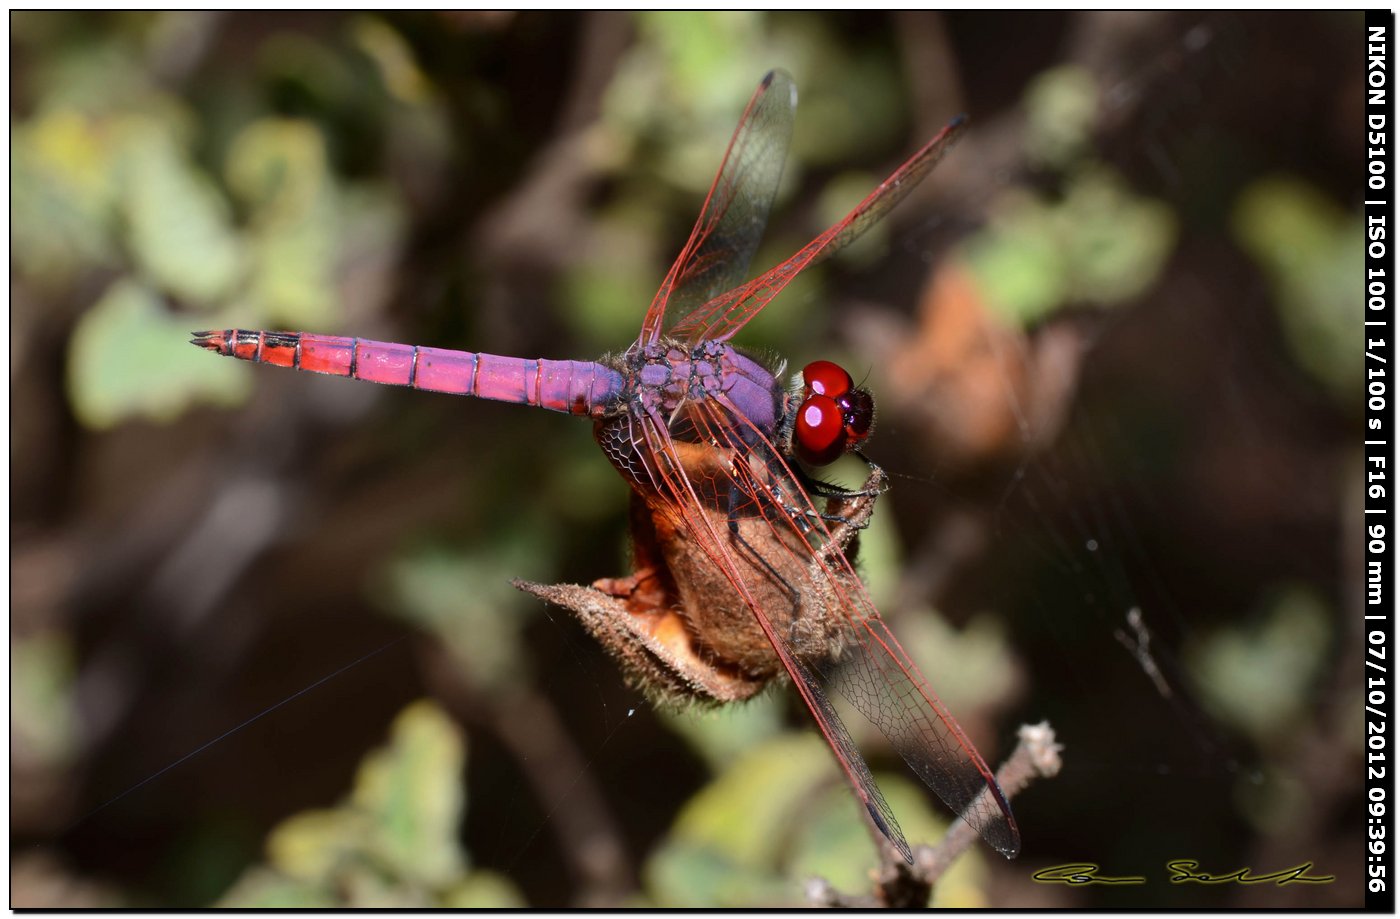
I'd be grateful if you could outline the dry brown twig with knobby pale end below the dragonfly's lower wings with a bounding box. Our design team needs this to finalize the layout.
[806,721,1063,909]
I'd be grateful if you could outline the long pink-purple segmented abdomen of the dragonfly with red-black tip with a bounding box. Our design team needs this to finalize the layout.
[192,329,623,417]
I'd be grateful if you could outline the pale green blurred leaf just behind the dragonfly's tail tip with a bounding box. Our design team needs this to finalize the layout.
[69,279,252,429]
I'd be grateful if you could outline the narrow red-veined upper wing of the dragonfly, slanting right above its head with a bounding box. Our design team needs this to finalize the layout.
[671,116,967,342]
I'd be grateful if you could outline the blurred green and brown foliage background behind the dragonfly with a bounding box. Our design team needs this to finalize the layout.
[10,13,1364,906]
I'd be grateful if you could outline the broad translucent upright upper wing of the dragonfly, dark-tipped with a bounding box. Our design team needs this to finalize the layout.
[638,70,797,343]
